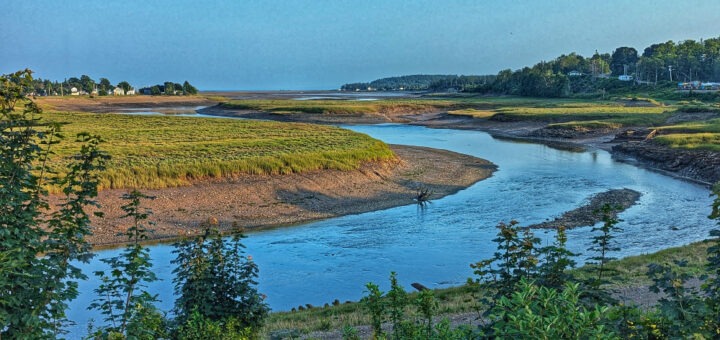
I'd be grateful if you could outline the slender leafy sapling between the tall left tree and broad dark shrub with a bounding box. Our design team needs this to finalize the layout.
[88,190,164,338]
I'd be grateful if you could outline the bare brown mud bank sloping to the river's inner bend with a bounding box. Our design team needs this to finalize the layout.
[73,146,496,246]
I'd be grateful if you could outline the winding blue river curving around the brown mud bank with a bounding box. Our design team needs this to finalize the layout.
[64,125,714,338]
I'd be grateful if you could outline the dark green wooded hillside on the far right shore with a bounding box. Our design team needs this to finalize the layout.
[341,38,720,97]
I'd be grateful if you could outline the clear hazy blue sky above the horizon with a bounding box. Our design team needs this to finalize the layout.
[0,0,720,90]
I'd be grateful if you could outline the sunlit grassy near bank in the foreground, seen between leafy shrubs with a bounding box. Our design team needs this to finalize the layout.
[263,241,710,337]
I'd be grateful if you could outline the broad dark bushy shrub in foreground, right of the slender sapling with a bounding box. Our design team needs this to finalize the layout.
[172,228,269,329]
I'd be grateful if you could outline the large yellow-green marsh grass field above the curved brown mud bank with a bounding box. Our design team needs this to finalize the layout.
[44,113,394,188]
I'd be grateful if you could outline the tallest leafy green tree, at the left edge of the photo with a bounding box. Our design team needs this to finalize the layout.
[0,70,108,339]
